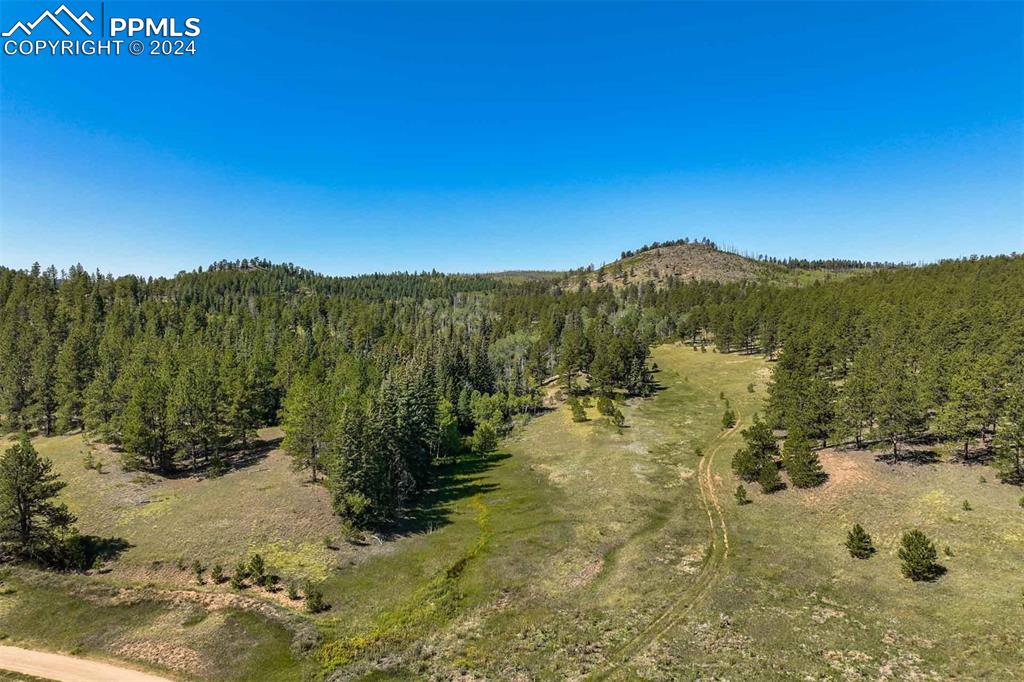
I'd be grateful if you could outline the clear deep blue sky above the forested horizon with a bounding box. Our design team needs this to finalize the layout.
[0,0,1024,274]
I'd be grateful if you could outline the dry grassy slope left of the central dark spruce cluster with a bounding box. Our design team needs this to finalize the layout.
[28,429,369,587]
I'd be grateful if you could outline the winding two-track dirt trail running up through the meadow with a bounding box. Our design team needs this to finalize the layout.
[590,420,739,680]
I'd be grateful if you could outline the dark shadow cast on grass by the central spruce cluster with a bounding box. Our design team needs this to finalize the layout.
[386,453,511,537]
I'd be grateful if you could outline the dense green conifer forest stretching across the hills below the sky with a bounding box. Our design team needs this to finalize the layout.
[0,244,1024,523]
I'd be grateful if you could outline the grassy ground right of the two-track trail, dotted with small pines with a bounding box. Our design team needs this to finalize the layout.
[624,382,1024,679]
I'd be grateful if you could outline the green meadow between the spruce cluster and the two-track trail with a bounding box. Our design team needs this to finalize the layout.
[309,346,765,679]
